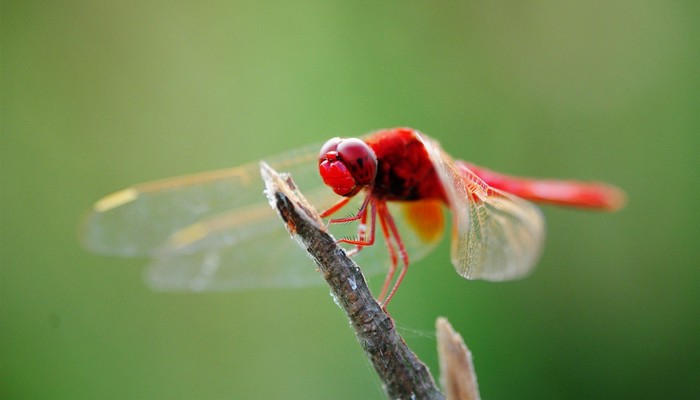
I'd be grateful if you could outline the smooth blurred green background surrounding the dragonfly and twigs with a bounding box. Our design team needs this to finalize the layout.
[0,0,700,399]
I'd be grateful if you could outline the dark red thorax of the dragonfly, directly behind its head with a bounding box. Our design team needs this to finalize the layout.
[364,128,446,201]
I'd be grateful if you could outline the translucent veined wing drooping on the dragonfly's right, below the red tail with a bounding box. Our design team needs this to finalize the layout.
[423,133,545,281]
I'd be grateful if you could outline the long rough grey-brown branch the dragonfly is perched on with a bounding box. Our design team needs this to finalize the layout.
[260,162,444,399]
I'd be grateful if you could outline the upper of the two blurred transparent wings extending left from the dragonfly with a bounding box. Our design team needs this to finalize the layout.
[80,144,321,257]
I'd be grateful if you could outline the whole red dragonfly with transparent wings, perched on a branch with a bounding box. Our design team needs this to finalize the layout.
[81,128,625,305]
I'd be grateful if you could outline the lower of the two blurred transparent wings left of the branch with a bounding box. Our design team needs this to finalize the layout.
[146,189,336,291]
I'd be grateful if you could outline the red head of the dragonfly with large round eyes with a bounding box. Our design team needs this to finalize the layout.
[318,137,377,197]
